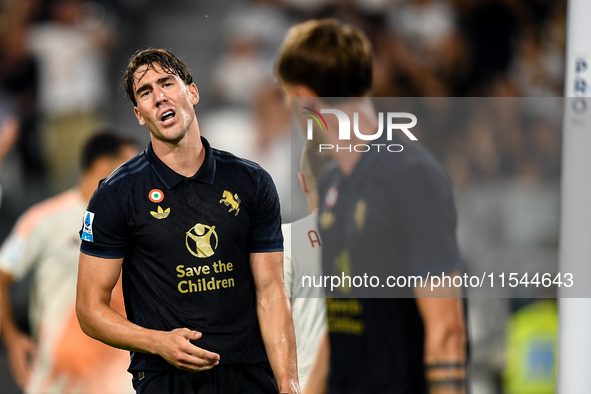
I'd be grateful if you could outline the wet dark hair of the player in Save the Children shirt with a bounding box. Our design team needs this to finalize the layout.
[123,48,193,107]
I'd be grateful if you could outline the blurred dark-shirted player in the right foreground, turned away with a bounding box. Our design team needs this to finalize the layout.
[276,20,467,394]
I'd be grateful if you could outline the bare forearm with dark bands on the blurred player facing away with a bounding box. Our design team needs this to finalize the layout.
[415,278,467,394]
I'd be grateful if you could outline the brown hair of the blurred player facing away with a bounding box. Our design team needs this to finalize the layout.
[275,19,372,97]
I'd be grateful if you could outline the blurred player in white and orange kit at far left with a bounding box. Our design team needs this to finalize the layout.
[0,131,137,394]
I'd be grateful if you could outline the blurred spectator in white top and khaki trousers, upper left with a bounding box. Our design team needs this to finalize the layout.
[28,0,113,191]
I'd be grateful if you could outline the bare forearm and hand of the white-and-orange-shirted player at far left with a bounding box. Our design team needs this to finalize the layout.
[0,270,37,389]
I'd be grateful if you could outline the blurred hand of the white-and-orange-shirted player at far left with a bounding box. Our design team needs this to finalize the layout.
[6,332,37,389]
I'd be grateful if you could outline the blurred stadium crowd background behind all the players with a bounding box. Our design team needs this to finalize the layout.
[0,0,566,394]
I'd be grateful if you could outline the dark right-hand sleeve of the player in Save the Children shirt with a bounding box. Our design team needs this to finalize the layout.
[248,168,283,253]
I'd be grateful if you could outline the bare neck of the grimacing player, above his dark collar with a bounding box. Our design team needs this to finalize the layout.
[152,127,205,177]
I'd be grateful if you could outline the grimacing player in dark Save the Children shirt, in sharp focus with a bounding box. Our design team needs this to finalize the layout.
[77,49,299,394]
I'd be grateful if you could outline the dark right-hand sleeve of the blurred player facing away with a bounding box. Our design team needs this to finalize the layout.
[396,162,461,276]
